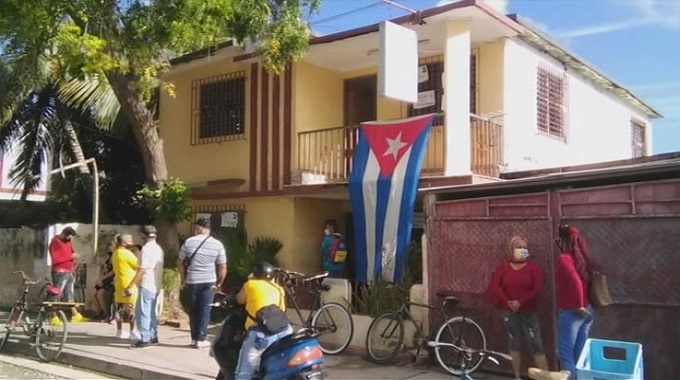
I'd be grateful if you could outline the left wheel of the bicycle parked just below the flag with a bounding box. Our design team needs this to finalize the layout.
[366,311,404,364]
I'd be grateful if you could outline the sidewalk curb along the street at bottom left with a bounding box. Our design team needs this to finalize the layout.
[3,341,210,380]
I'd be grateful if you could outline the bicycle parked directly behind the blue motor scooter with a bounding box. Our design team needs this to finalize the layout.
[277,269,354,355]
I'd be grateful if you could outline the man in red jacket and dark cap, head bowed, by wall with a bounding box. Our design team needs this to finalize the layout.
[48,227,85,325]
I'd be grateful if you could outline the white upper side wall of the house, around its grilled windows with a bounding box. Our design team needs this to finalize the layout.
[503,39,651,171]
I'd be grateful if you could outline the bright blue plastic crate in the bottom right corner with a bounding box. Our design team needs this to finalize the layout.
[576,339,644,380]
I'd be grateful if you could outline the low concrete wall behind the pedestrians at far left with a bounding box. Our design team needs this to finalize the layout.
[0,223,141,309]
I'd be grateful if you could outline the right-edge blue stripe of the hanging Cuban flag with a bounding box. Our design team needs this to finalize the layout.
[393,121,432,282]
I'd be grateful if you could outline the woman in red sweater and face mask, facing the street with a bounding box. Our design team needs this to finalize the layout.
[490,236,548,379]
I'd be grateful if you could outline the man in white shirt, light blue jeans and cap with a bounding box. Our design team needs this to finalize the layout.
[126,226,163,348]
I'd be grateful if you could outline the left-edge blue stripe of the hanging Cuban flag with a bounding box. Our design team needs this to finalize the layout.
[348,129,371,282]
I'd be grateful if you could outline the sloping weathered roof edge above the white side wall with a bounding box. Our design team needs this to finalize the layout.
[509,15,663,119]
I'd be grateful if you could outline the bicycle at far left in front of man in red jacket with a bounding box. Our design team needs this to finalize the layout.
[0,271,76,362]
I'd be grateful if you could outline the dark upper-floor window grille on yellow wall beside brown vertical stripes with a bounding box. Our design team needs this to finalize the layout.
[191,71,246,145]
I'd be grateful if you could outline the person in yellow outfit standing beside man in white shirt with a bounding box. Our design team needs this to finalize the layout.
[111,234,139,340]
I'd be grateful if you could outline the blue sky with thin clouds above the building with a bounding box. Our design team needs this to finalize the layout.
[312,0,680,154]
